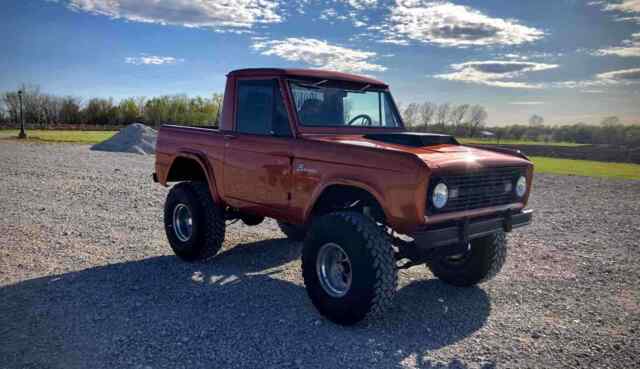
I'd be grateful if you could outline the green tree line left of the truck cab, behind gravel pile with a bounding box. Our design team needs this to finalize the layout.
[0,85,222,128]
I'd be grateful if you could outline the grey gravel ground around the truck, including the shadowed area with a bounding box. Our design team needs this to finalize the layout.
[0,141,640,369]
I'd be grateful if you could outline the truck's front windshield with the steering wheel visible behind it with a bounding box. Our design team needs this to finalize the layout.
[291,82,400,128]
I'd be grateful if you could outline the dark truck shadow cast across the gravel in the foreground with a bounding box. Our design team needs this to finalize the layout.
[0,240,494,369]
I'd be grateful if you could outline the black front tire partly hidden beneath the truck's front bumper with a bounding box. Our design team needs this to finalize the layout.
[429,231,507,287]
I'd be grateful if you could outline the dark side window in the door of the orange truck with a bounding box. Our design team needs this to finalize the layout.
[236,79,291,137]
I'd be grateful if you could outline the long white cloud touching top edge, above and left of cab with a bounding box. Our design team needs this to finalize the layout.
[68,0,282,28]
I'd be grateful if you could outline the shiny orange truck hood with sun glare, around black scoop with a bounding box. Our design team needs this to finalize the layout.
[305,133,531,170]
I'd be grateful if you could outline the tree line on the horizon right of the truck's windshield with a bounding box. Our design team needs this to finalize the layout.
[400,101,640,147]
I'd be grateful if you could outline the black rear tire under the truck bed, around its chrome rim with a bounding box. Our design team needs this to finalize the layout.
[164,182,225,261]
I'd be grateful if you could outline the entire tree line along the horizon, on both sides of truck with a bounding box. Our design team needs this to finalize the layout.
[0,85,640,147]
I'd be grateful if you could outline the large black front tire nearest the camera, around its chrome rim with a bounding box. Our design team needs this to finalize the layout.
[302,212,398,325]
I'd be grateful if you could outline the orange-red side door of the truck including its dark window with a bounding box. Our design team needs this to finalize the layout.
[224,79,292,210]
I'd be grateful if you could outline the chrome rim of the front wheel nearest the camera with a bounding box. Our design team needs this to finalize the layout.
[316,242,353,297]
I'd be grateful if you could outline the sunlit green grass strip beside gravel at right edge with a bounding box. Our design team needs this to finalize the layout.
[530,156,640,179]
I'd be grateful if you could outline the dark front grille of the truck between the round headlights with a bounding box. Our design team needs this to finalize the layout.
[427,167,525,214]
